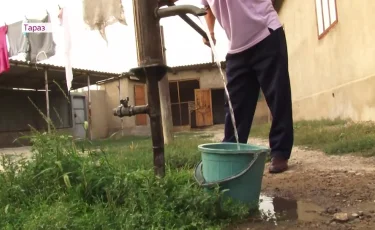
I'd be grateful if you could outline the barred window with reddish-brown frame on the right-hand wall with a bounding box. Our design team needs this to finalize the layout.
[315,0,338,39]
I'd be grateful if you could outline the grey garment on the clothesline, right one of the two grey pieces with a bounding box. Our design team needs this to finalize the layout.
[26,14,56,63]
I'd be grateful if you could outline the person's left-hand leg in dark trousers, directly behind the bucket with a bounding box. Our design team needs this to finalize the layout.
[223,51,260,143]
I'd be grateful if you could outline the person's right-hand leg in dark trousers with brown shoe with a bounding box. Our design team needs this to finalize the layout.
[252,28,293,173]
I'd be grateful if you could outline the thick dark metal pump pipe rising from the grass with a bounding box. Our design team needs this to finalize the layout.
[133,0,165,177]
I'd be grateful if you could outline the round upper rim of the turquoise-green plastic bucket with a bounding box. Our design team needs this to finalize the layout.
[198,142,271,154]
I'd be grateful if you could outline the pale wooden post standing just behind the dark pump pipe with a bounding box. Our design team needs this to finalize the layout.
[159,26,173,145]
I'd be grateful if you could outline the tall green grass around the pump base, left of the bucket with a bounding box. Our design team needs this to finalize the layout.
[0,130,247,230]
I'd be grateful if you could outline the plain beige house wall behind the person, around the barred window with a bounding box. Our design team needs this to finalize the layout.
[279,0,375,121]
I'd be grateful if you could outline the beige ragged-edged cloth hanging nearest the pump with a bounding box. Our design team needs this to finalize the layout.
[83,0,127,42]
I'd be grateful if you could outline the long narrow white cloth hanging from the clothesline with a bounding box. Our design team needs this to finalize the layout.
[59,6,73,91]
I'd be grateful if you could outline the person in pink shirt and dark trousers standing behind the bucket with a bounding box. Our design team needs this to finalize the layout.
[201,0,294,173]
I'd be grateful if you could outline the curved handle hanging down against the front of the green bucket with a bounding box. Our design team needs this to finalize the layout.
[194,152,262,187]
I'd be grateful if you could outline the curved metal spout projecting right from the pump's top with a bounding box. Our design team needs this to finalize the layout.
[156,5,207,18]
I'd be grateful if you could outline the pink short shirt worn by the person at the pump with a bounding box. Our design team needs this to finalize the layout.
[201,0,281,54]
